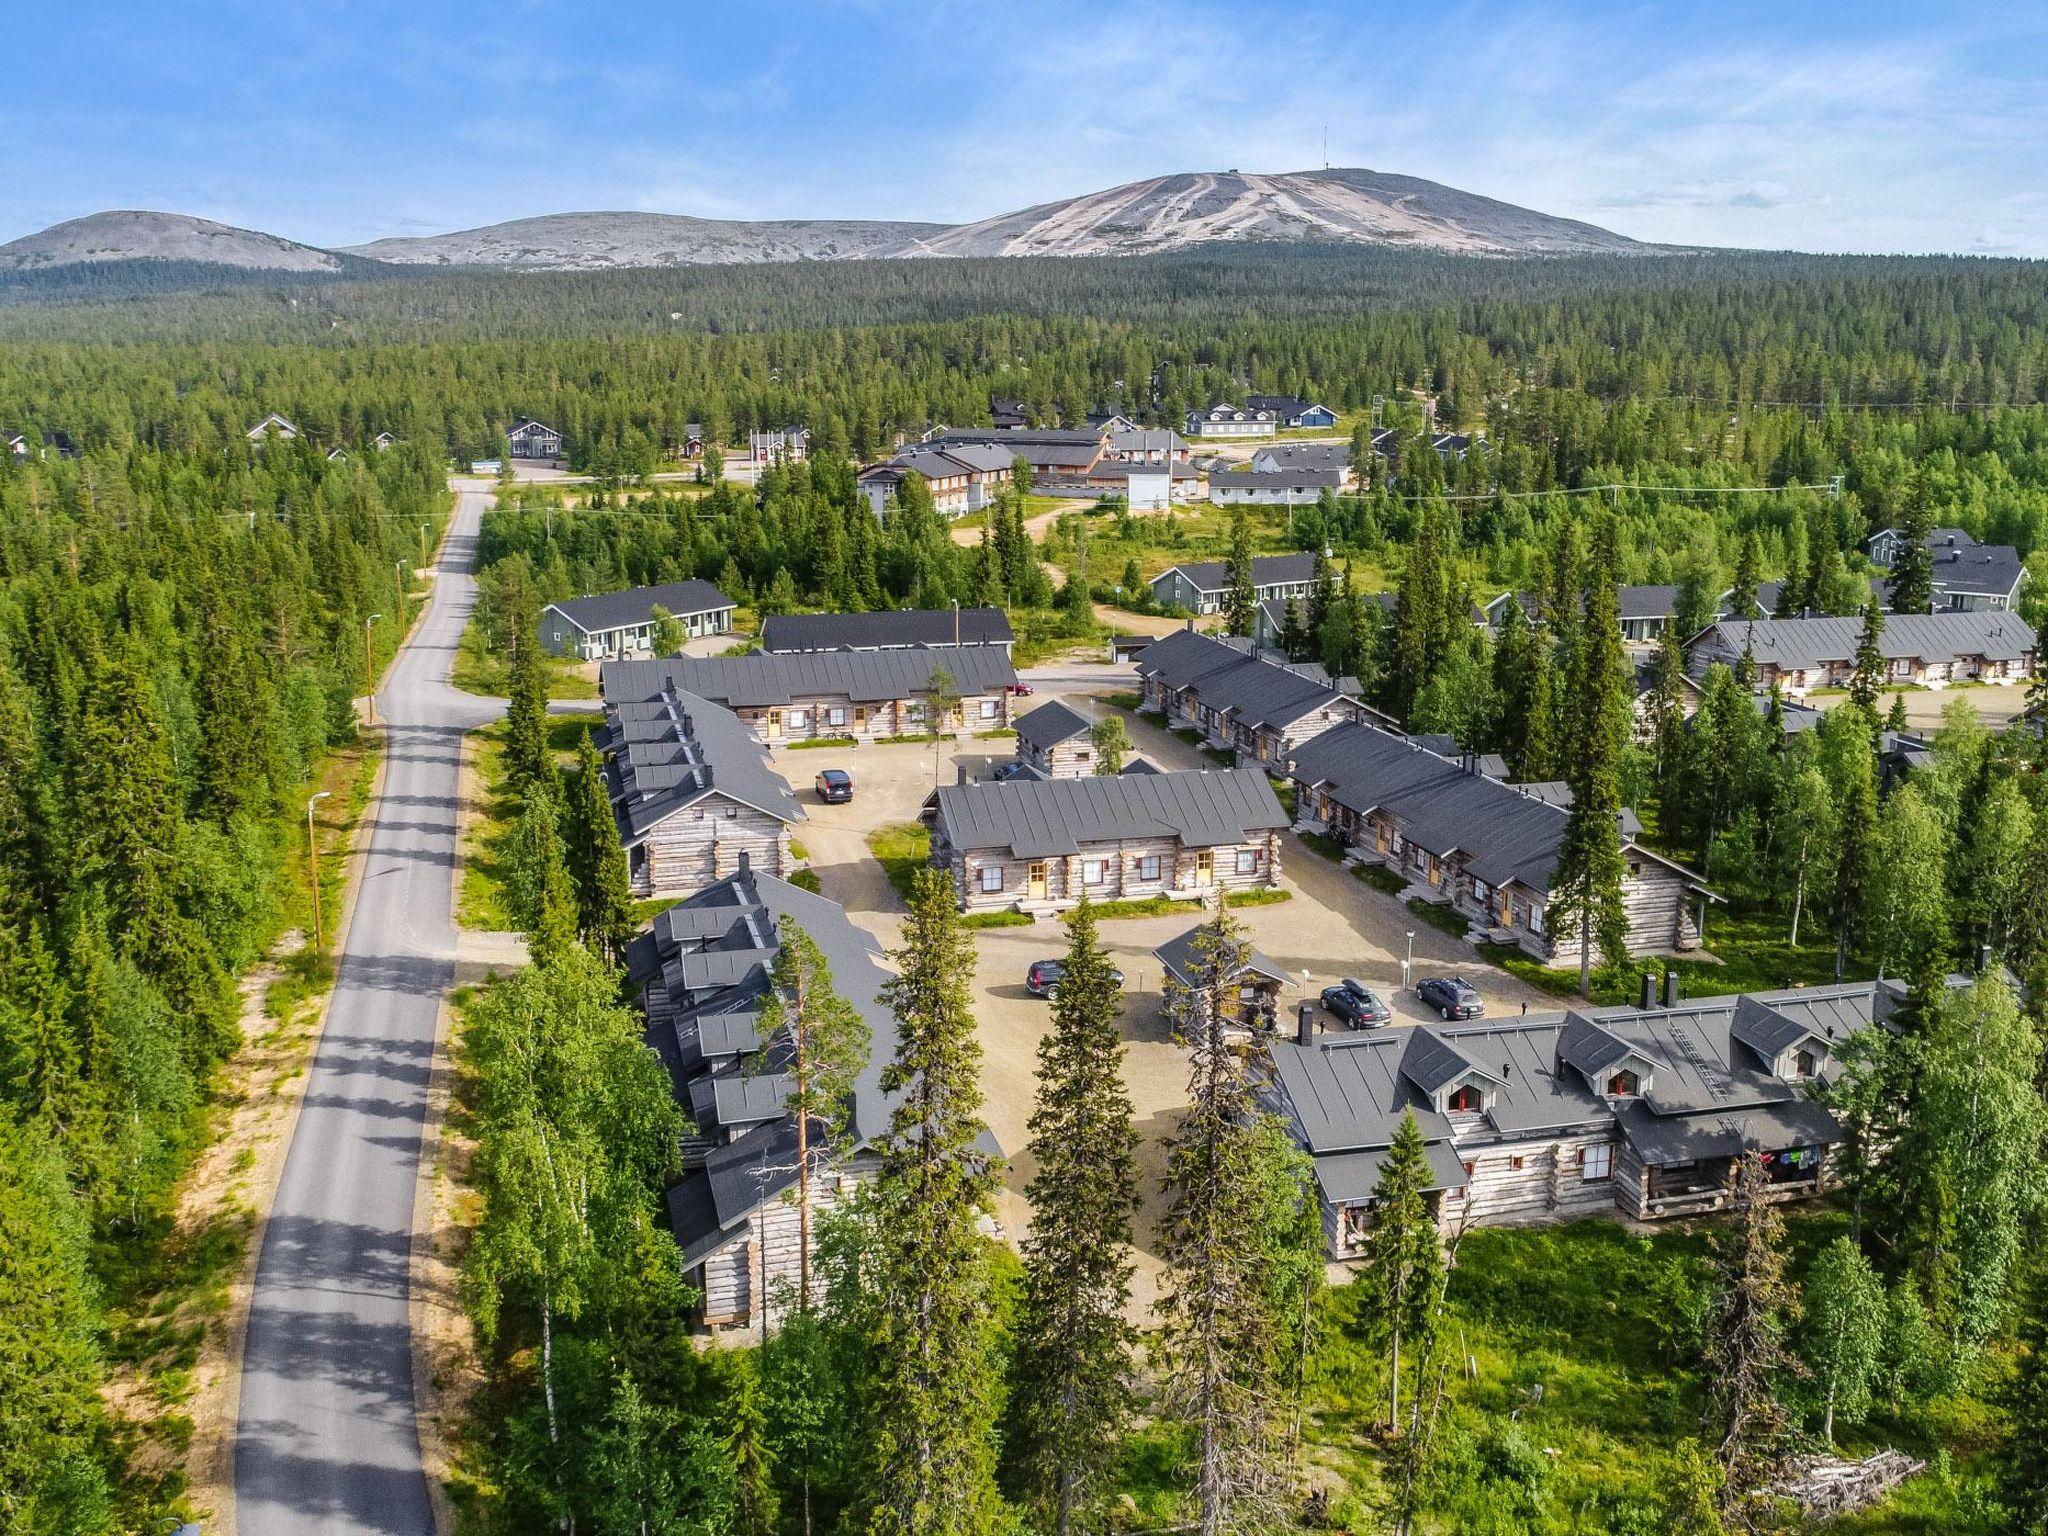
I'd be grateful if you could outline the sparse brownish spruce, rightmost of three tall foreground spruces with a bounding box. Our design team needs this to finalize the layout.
[1157,911,1296,1536]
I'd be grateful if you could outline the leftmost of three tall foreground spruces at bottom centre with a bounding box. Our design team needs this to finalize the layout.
[864,870,999,1536]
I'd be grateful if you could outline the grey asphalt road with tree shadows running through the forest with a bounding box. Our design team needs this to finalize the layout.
[236,481,496,1536]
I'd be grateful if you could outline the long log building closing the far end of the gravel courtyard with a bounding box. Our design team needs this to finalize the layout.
[598,645,1018,745]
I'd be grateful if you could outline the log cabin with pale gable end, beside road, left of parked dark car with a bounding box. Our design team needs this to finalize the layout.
[596,688,805,899]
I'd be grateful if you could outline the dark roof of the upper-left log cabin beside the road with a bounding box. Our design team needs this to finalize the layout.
[598,688,805,848]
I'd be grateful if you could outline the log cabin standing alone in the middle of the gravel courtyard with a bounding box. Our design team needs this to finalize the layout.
[932,768,1286,915]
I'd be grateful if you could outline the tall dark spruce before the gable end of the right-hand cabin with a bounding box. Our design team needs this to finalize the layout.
[1550,518,1628,995]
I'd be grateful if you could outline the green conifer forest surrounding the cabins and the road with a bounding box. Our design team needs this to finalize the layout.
[0,250,2048,1536]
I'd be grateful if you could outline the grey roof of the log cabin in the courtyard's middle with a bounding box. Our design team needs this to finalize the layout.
[936,768,1288,858]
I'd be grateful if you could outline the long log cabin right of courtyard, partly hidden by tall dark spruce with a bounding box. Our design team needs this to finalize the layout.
[1290,725,1712,965]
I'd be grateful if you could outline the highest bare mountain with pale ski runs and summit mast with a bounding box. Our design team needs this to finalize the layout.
[901,170,1645,256]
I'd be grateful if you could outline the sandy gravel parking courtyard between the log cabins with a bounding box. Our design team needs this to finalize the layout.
[774,694,1554,1313]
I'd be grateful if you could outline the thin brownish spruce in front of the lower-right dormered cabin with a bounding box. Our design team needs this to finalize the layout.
[1706,1153,1796,1507]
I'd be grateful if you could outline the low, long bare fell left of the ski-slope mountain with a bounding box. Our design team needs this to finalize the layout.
[348,213,946,270]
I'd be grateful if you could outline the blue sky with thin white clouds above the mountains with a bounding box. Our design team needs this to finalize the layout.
[12,0,2048,256]
